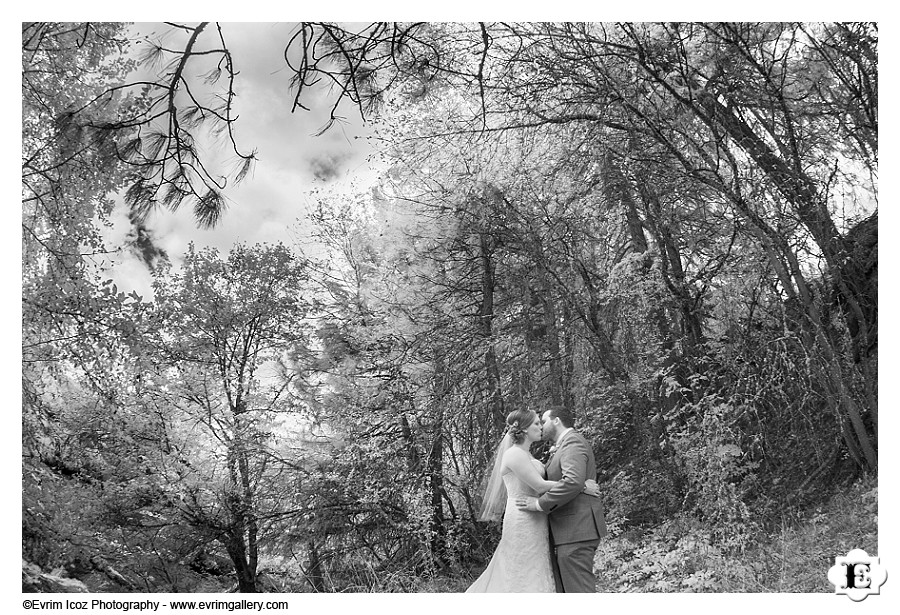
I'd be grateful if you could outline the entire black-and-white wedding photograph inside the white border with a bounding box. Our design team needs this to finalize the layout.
[17,16,884,612]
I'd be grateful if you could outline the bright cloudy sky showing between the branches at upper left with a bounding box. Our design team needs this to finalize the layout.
[108,23,377,294]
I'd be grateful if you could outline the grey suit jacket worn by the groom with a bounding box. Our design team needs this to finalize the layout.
[538,431,606,545]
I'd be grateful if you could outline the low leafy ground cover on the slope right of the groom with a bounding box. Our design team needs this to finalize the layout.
[595,478,878,593]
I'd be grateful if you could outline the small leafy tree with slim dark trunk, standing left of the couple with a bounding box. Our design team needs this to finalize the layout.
[148,244,310,592]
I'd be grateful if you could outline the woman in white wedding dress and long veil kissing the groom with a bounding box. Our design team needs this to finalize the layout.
[466,410,599,593]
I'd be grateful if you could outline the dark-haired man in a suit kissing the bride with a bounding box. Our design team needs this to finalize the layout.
[516,407,606,593]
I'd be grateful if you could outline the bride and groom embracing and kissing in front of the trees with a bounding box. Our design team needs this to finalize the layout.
[466,407,606,593]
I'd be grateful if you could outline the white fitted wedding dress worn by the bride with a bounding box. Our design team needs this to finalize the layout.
[466,459,556,594]
